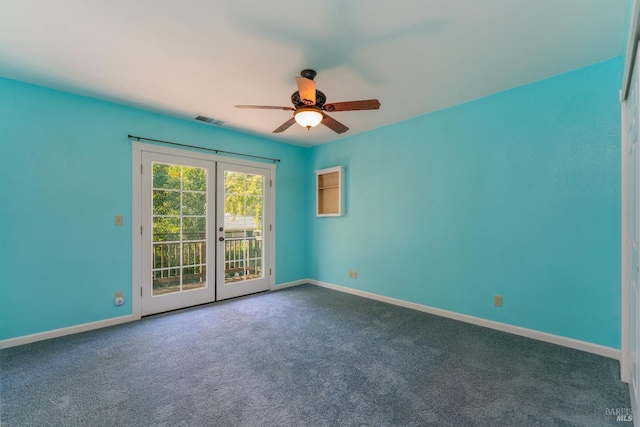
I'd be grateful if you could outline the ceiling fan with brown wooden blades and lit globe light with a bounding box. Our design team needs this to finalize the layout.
[236,70,380,133]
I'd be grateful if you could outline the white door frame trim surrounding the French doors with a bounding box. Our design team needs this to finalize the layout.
[131,141,276,319]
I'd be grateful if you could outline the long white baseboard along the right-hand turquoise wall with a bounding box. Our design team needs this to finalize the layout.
[310,279,620,360]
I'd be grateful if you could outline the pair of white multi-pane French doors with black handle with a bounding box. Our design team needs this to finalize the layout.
[140,151,272,315]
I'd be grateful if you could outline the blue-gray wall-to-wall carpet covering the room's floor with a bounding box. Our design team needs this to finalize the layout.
[0,285,631,427]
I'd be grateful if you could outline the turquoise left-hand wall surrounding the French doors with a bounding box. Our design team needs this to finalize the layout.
[0,79,308,340]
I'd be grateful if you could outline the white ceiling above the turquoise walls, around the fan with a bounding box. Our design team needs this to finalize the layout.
[0,0,630,146]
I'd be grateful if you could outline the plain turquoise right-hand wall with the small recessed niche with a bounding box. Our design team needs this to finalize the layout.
[308,58,622,348]
